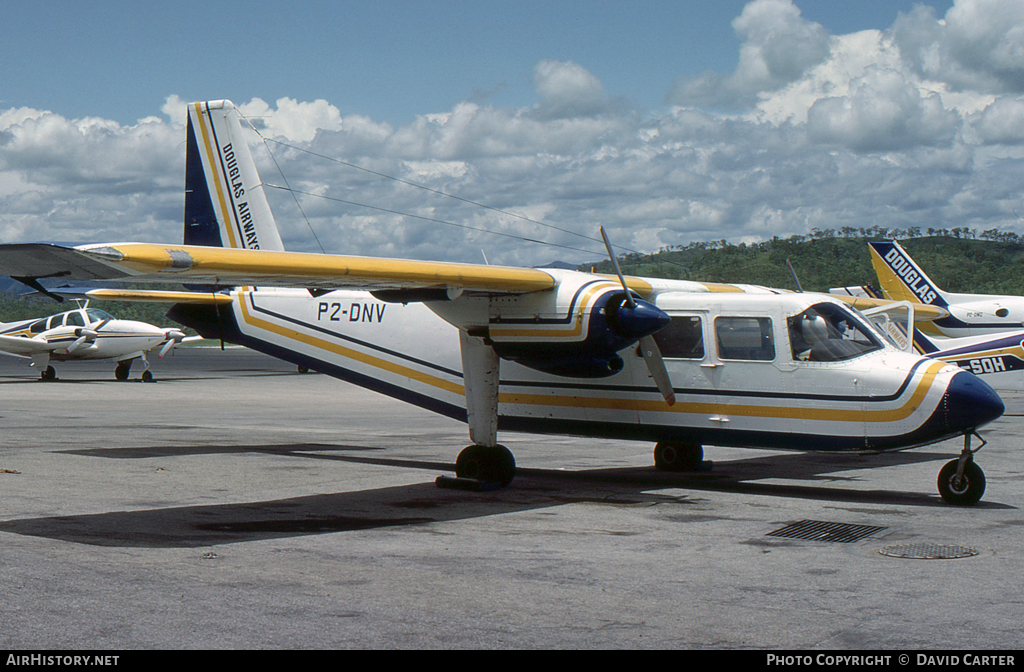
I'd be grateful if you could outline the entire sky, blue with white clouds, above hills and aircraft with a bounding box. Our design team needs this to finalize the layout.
[0,0,1024,264]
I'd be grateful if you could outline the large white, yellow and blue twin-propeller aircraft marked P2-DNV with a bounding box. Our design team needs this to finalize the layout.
[0,100,1004,504]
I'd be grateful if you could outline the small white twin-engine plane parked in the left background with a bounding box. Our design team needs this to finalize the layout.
[0,303,195,381]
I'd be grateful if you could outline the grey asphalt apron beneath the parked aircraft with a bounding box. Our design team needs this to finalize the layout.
[0,348,1024,654]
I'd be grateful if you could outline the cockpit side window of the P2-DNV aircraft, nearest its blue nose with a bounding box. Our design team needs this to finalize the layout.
[788,303,883,362]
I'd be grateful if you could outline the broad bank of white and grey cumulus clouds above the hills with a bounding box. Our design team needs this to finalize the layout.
[0,0,1024,264]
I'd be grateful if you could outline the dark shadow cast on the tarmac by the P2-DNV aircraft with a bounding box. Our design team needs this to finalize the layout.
[0,444,1012,548]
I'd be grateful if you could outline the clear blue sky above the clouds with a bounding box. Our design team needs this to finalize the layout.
[0,0,952,124]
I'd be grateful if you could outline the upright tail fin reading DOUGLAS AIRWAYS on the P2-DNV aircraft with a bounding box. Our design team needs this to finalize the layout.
[183,100,285,251]
